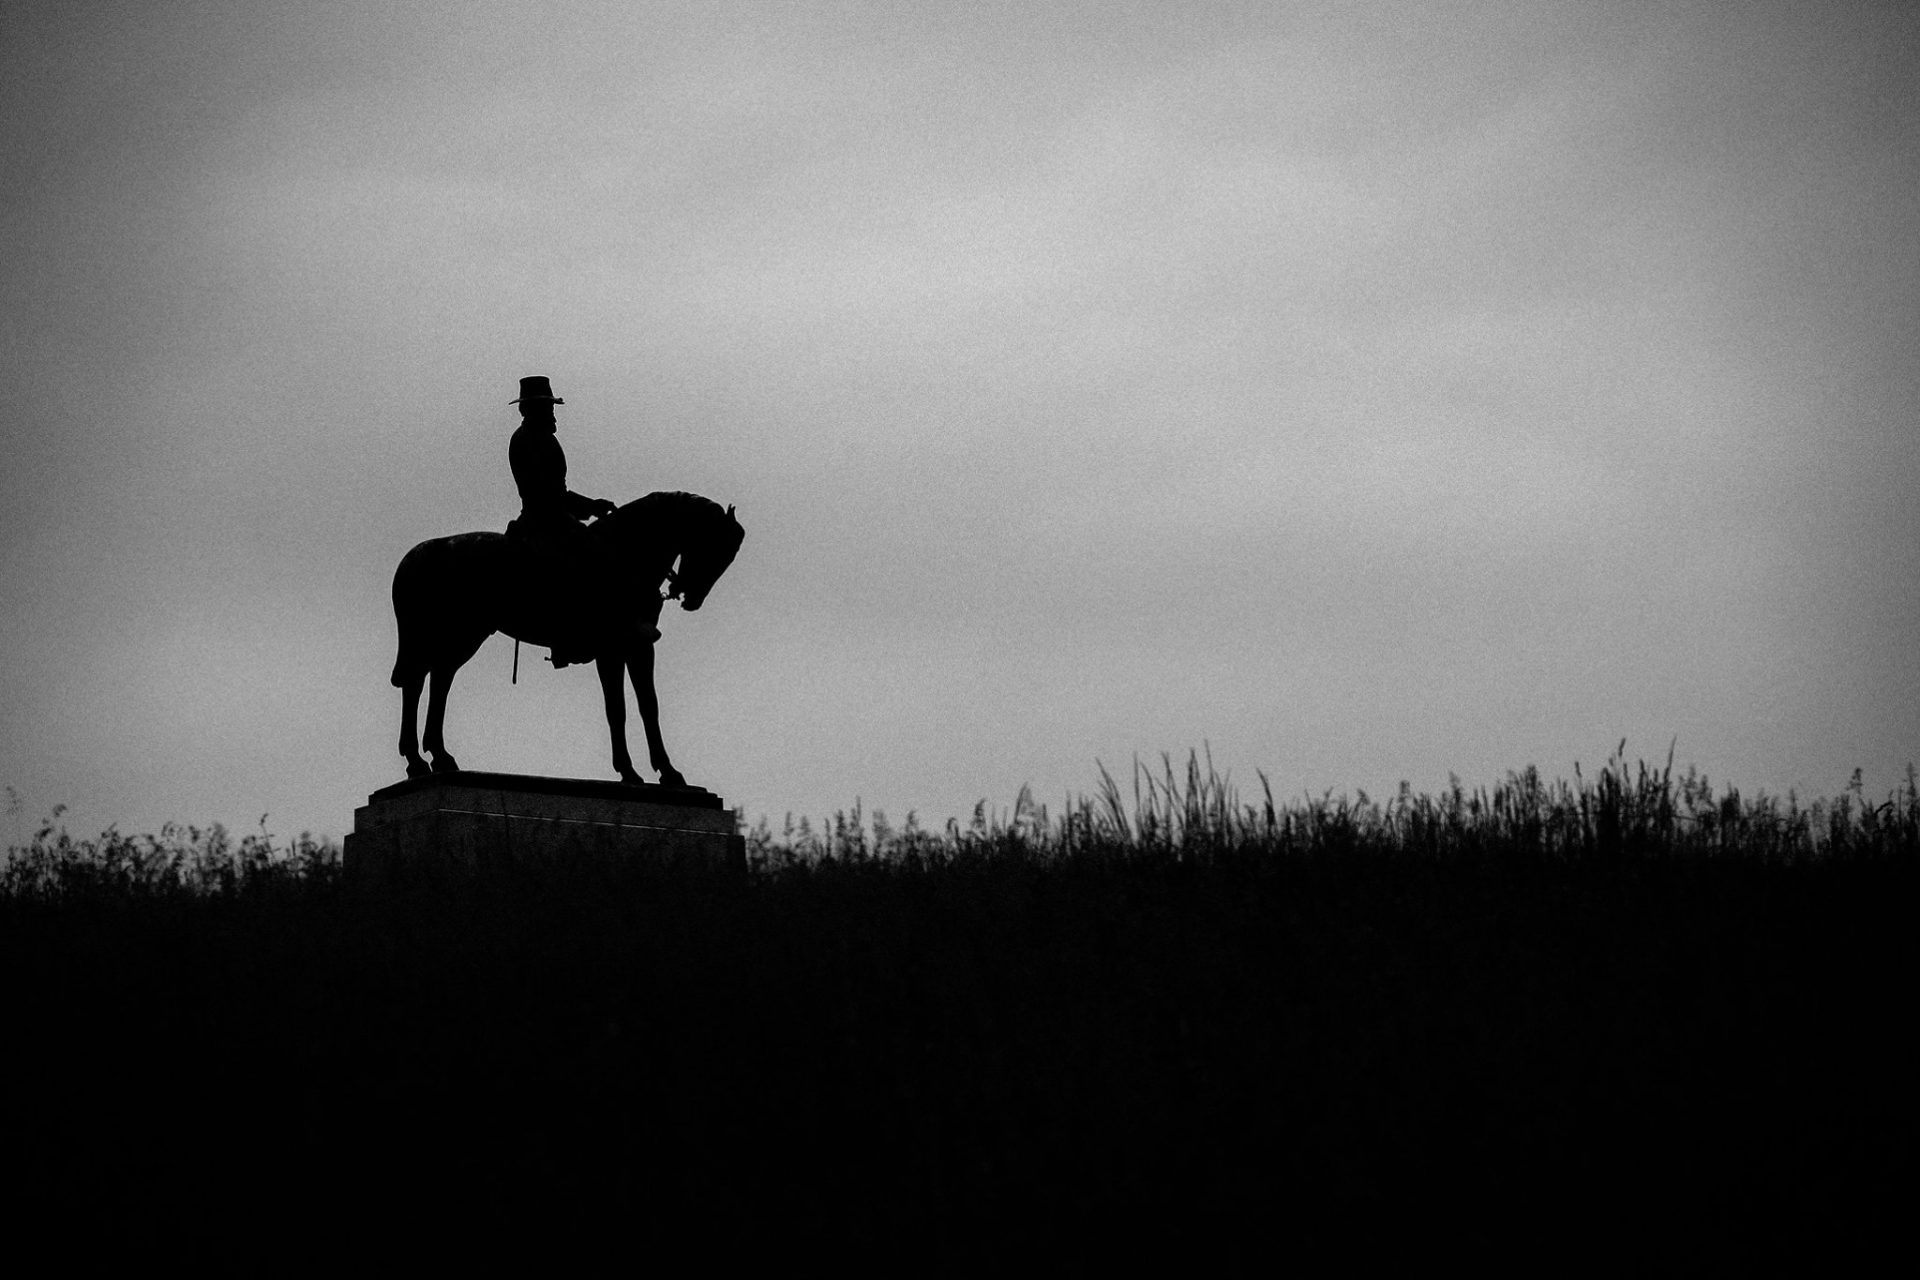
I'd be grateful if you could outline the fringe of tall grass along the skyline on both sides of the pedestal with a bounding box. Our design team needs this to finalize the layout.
[11,741,1920,900]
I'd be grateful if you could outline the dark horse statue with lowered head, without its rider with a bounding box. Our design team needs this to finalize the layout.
[394,493,747,787]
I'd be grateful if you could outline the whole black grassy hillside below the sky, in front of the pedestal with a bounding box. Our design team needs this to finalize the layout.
[0,760,1920,1272]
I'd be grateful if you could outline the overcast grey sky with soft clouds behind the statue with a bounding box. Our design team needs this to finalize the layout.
[0,0,1920,839]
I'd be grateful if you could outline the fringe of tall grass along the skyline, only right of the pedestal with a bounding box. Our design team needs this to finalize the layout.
[747,741,1920,869]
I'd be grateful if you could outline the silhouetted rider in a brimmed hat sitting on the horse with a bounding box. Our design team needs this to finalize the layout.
[507,378,614,666]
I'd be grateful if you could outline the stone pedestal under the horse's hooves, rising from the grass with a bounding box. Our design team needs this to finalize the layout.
[342,771,747,879]
